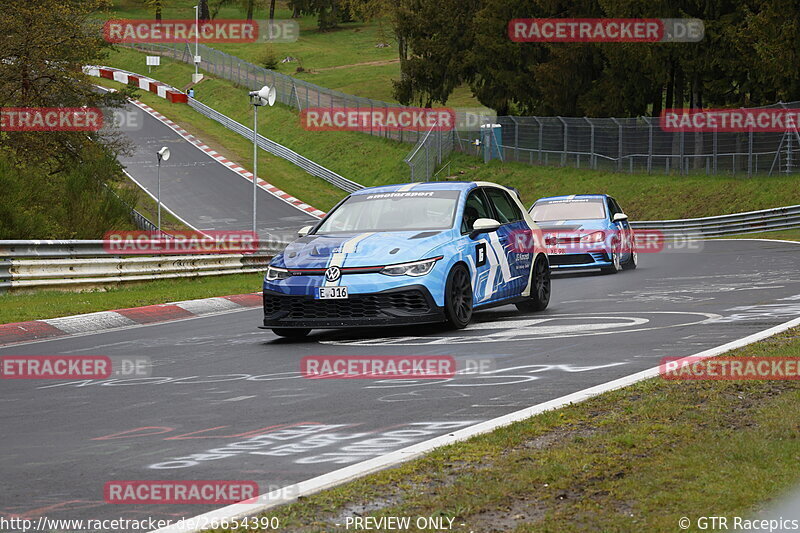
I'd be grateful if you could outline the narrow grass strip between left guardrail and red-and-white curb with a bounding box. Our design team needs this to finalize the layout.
[0,274,261,324]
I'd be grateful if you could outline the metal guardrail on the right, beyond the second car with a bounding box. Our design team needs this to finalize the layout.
[631,205,800,238]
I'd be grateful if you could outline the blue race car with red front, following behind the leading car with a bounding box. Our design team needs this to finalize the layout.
[530,194,638,274]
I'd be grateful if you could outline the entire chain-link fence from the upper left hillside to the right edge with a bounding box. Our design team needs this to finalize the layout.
[126,43,800,181]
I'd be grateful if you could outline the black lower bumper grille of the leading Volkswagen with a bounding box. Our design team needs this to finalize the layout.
[264,289,431,320]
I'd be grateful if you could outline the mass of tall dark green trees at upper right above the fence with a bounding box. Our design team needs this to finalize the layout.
[394,0,800,116]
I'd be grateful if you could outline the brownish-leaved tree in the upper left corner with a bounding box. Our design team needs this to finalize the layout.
[0,0,134,172]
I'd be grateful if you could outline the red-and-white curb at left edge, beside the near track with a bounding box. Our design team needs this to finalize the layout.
[0,292,261,346]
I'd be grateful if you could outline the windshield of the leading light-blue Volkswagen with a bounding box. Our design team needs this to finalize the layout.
[315,190,460,235]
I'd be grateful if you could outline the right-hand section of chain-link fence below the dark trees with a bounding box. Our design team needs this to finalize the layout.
[459,106,800,176]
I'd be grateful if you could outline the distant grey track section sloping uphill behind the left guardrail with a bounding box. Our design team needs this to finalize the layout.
[115,99,316,238]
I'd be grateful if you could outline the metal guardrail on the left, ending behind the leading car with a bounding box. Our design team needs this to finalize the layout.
[0,240,286,291]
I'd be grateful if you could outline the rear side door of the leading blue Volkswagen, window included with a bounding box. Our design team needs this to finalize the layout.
[486,187,533,298]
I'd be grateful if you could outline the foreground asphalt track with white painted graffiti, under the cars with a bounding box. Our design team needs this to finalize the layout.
[0,239,800,518]
